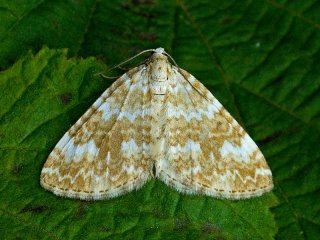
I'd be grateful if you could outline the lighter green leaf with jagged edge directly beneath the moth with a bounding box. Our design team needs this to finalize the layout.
[0,48,275,239]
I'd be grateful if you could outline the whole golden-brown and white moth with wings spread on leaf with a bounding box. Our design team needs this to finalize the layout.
[40,48,273,200]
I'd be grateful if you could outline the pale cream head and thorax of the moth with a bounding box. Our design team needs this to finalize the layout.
[148,52,172,95]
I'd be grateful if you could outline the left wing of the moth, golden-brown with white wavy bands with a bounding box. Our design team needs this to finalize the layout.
[40,67,152,199]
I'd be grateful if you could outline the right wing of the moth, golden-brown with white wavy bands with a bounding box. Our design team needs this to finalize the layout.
[157,68,273,199]
